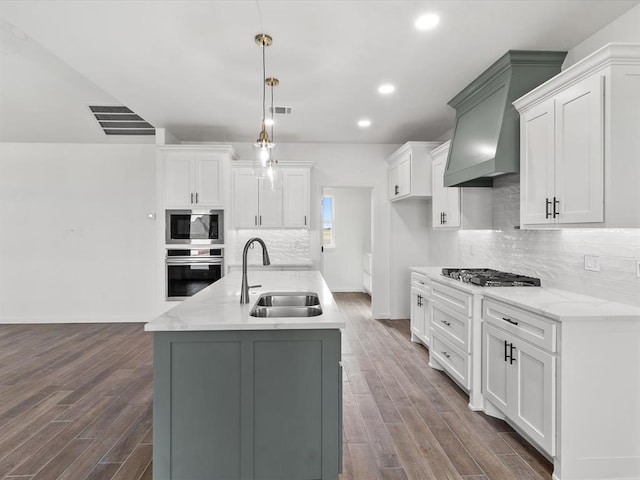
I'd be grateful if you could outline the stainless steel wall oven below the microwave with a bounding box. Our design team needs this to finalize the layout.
[166,248,224,300]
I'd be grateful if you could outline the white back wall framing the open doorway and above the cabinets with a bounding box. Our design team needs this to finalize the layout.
[233,143,400,318]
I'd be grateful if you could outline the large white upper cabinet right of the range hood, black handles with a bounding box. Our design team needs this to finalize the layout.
[514,44,640,228]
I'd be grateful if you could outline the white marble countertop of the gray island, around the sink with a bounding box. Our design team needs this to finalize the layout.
[144,270,346,332]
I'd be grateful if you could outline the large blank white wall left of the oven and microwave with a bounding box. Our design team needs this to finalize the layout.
[0,143,157,323]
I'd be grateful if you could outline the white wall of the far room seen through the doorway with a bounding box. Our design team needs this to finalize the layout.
[322,188,371,292]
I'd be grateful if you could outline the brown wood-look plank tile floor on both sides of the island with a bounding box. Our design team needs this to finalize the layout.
[0,293,552,480]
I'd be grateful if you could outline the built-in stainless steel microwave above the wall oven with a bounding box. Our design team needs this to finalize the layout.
[166,210,224,245]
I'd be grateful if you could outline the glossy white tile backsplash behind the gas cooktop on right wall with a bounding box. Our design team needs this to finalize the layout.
[458,175,640,306]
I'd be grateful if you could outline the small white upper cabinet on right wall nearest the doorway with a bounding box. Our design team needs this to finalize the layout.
[387,142,438,202]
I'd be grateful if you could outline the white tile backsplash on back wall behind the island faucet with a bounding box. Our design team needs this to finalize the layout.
[225,230,311,265]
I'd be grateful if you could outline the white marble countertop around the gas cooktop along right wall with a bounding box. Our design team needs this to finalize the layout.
[410,267,640,321]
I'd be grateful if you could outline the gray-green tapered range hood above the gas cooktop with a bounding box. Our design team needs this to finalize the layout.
[444,50,567,187]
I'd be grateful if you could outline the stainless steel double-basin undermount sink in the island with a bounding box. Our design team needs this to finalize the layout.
[249,292,322,317]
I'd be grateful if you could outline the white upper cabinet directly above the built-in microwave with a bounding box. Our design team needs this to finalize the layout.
[160,146,235,208]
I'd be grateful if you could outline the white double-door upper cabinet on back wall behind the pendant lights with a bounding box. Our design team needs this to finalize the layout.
[233,167,310,228]
